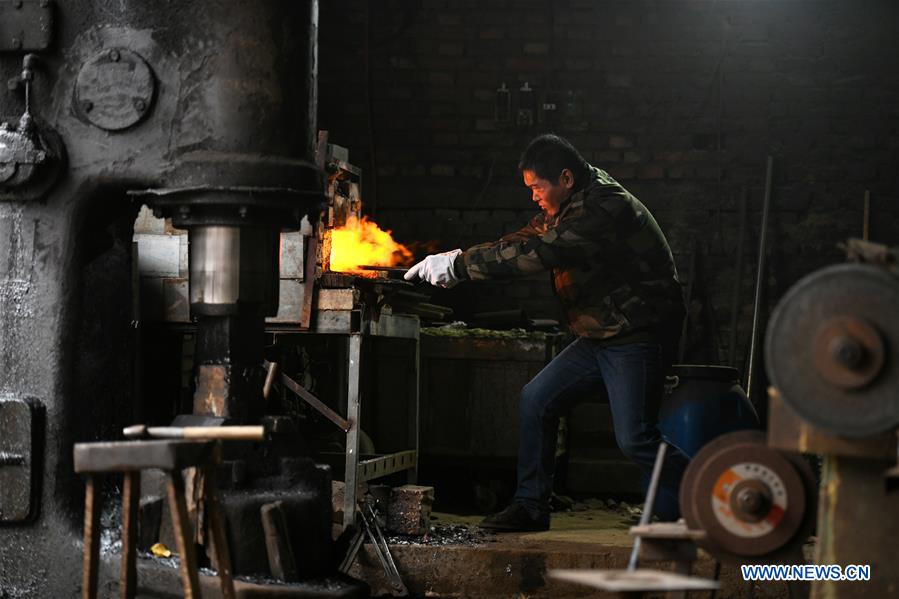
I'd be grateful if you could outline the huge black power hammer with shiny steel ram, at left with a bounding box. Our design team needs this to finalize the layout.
[0,0,384,597]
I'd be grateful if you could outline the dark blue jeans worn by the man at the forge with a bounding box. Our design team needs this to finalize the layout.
[515,338,689,520]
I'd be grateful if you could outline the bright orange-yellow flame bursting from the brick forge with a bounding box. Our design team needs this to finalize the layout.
[331,216,412,273]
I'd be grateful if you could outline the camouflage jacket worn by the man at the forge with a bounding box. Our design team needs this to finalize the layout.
[454,168,684,339]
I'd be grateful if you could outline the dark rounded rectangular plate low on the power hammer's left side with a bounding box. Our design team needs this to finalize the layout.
[0,397,37,522]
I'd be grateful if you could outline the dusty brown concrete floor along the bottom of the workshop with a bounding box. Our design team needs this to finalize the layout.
[123,502,810,599]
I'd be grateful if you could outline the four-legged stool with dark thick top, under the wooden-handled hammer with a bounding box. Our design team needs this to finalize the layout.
[75,440,235,599]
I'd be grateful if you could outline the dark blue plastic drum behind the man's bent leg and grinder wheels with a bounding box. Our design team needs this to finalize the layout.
[659,364,760,458]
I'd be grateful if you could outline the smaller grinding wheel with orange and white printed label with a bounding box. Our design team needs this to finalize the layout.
[680,431,817,563]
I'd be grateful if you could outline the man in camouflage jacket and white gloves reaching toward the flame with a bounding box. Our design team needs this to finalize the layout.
[406,135,688,531]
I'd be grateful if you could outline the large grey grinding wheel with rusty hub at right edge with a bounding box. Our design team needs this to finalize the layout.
[765,264,899,437]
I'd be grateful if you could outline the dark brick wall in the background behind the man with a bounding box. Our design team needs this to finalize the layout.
[319,0,899,365]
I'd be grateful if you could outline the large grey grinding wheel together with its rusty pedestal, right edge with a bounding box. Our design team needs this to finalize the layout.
[765,239,899,598]
